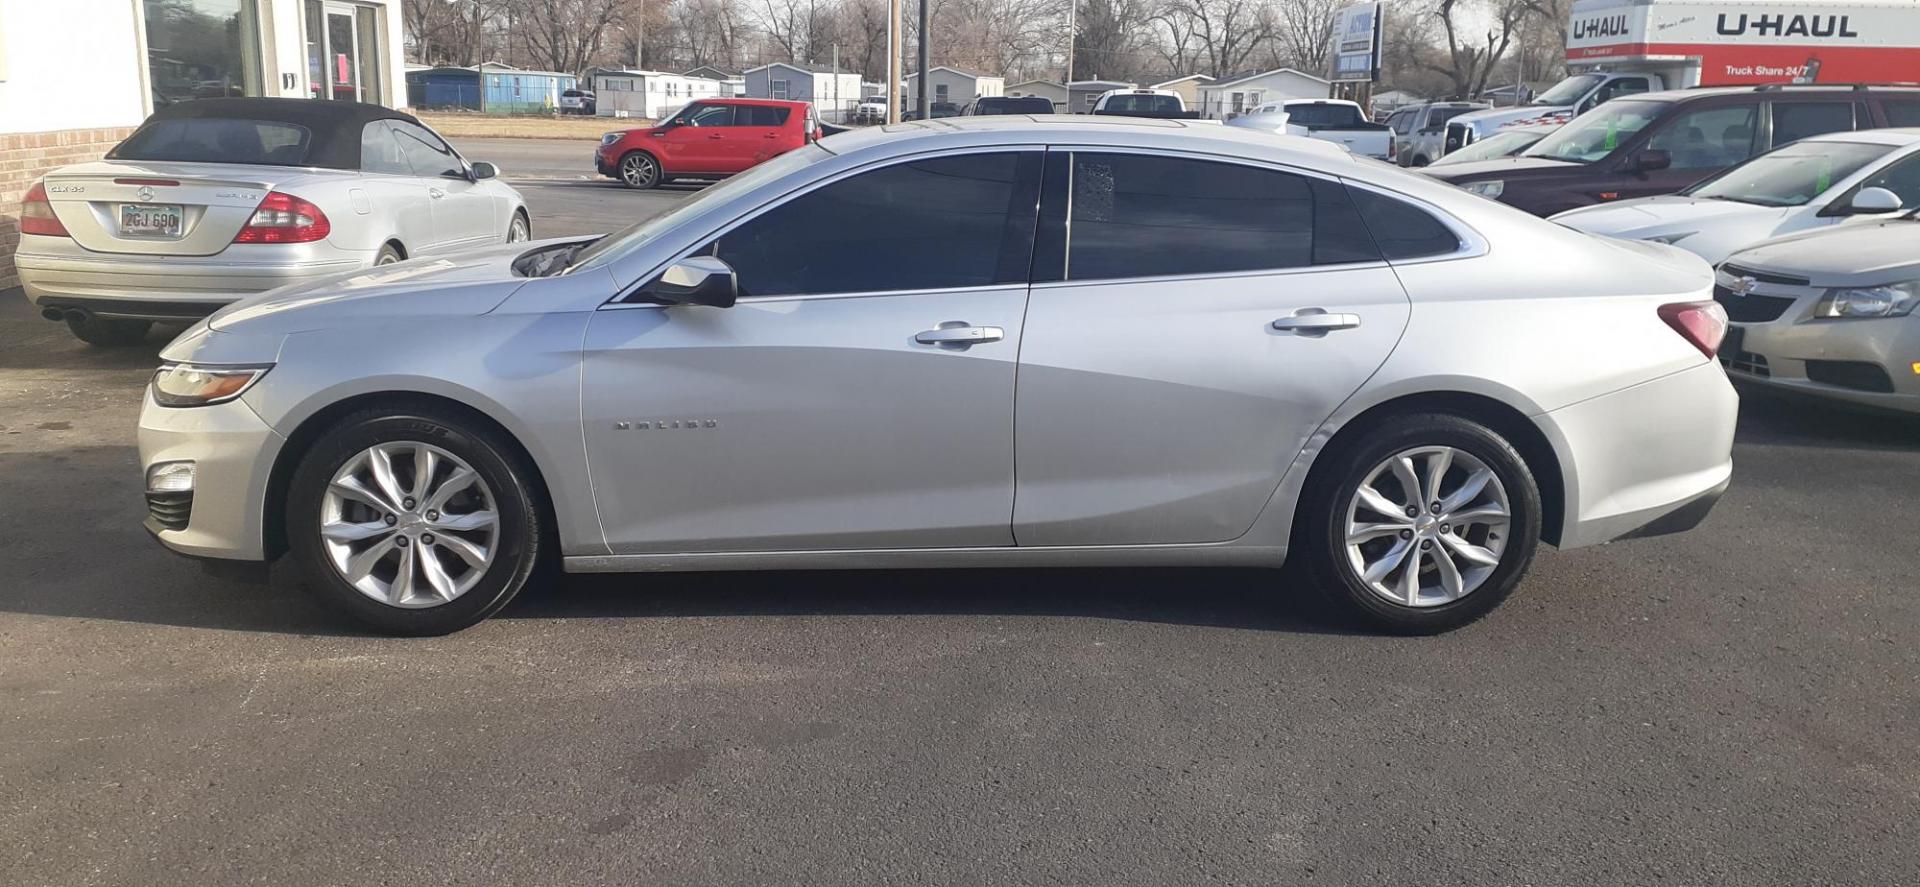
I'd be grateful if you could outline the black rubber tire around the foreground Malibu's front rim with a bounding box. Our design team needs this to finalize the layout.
[286,405,547,635]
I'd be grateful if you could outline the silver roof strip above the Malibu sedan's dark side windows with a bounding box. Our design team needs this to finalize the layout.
[816,113,1354,167]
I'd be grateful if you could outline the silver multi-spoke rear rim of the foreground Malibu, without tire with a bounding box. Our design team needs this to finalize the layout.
[1346,447,1513,607]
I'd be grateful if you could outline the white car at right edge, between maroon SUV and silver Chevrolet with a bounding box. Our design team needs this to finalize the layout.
[1553,129,1920,263]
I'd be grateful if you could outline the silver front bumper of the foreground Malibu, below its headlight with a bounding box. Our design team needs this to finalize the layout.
[140,394,286,561]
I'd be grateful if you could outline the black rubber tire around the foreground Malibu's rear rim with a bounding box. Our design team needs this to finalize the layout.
[1288,413,1540,635]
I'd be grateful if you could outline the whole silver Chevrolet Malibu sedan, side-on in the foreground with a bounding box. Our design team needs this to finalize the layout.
[140,117,1736,634]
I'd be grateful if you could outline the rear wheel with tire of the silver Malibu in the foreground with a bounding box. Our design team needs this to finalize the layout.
[1292,413,1540,634]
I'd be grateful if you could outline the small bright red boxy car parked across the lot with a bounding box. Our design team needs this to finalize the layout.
[593,98,822,188]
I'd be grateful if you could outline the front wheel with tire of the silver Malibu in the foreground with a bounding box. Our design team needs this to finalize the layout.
[286,409,541,635]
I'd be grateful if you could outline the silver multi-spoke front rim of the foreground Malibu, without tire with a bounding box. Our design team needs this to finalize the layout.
[321,440,499,609]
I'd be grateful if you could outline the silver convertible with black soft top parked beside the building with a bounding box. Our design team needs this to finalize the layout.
[15,98,532,346]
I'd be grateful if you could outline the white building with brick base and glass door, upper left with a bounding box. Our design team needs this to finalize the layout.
[0,0,407,288]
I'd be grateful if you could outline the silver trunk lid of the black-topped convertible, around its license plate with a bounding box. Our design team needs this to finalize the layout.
[44,159,313,255]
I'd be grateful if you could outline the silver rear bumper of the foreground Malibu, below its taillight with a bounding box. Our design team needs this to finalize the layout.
[1538,363,1740,549]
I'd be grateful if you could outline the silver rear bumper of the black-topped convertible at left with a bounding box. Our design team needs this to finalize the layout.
[13,234,374,321]
